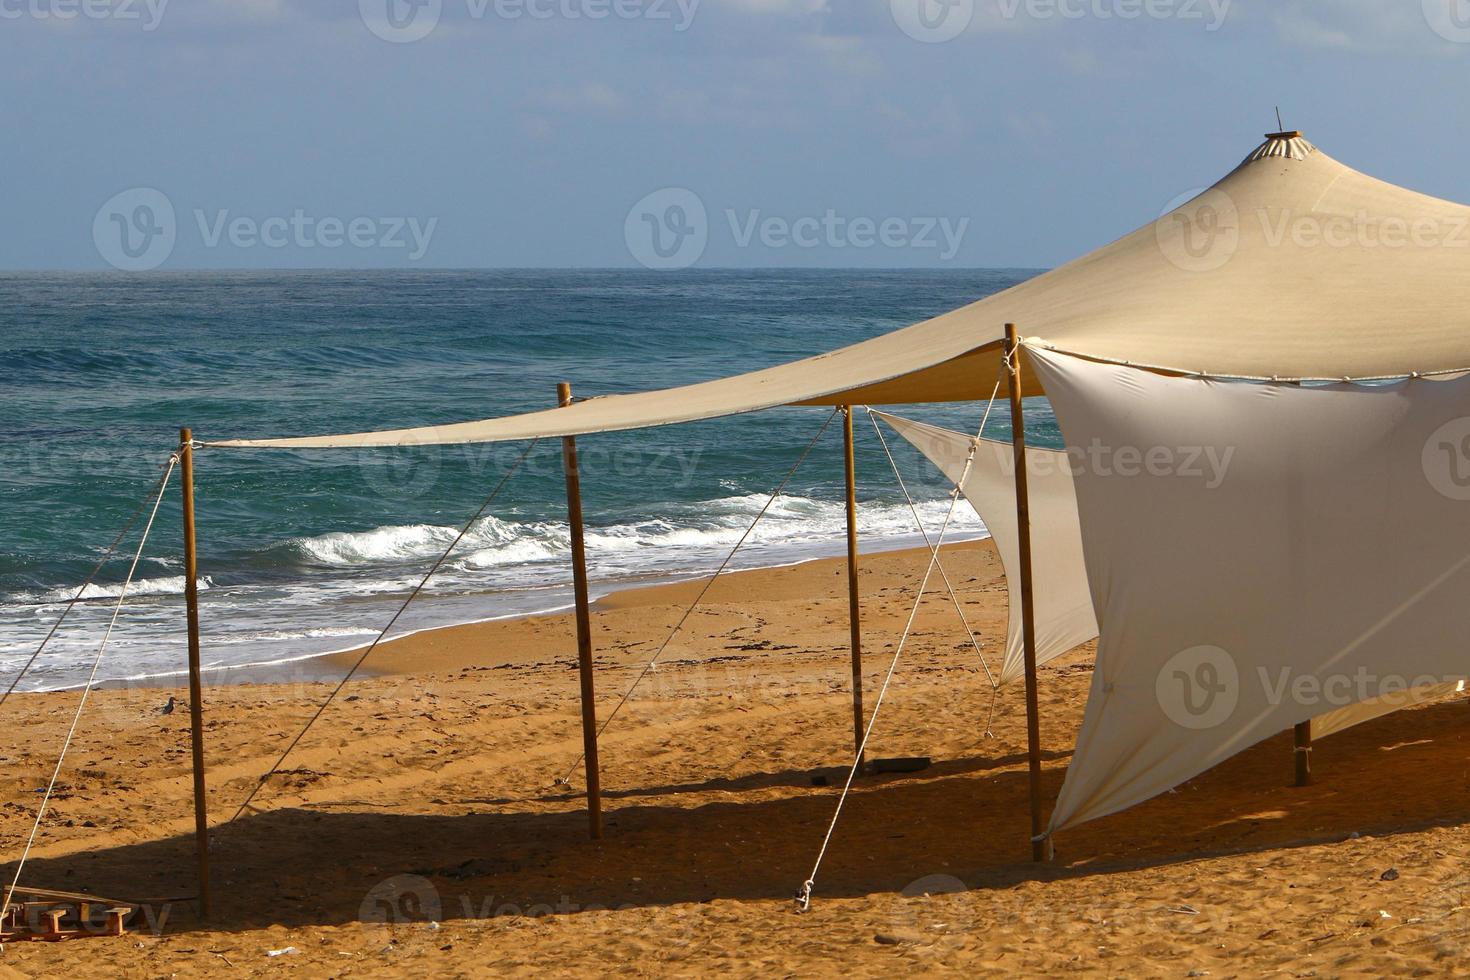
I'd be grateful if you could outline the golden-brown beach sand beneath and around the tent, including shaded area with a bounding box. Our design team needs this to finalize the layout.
[0,542,1470,977]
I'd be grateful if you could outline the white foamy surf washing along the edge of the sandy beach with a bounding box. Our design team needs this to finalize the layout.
[0,494,985,689]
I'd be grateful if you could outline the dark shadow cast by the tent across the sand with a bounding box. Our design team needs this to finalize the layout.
[6,701,1470,933]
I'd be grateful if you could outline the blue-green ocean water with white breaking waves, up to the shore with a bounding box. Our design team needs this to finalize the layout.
[0,270,1055,691]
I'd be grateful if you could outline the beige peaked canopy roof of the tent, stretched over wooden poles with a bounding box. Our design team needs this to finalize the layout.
[206,135,1470,448]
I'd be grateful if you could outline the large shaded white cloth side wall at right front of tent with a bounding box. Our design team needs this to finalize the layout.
[1030,350,1470,830]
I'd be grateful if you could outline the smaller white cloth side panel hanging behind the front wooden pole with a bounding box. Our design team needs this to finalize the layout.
[873,411,1098,683]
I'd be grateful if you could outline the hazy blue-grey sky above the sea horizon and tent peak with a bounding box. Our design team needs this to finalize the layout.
[0,0,1470,272]
